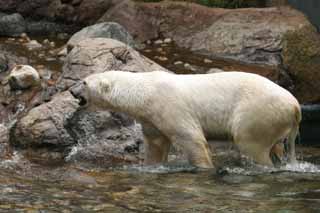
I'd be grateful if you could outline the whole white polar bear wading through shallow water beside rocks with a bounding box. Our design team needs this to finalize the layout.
[70,71,301,168]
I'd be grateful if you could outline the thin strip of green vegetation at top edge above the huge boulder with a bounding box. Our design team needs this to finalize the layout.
[136,0,265,8]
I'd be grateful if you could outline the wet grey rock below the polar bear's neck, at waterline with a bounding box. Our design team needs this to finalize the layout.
[67,111,142,167]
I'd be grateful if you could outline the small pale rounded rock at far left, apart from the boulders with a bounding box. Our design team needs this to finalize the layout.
[9,65,40,90]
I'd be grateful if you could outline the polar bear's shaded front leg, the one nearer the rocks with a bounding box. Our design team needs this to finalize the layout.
[143,123,171,165]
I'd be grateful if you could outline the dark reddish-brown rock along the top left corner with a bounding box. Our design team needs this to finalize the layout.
[0,0,122,25]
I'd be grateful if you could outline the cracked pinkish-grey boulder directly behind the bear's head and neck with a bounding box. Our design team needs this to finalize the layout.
[57,38,166,90]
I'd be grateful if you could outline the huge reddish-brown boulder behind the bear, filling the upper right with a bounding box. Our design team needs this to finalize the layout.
[100,1,320,103]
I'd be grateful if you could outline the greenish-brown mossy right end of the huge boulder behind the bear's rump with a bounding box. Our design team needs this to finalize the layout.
[282,25,320,103]
